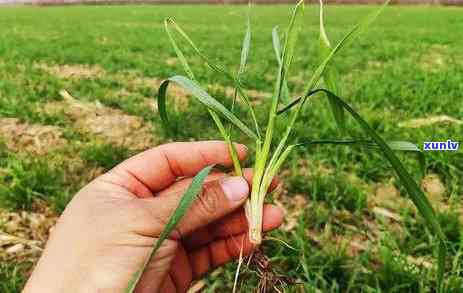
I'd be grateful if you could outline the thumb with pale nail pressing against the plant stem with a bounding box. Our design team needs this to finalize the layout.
[149,177,249,237]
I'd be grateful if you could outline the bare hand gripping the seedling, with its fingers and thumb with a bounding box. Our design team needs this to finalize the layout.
[23,141,283,293]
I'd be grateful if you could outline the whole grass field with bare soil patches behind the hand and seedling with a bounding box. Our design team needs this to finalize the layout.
[0,2,463,292]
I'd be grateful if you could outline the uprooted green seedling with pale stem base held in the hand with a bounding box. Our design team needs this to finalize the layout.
[127,1,446,290]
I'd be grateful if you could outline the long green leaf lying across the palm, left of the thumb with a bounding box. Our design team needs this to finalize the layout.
[125,166,214,293]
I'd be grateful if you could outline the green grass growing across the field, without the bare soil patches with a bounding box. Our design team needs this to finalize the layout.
[0,6,463,292]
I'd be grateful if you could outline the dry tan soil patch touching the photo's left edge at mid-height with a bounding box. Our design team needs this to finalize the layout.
[0,118,67,155]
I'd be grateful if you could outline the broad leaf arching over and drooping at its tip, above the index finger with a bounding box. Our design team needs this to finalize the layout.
[158,75,258,140]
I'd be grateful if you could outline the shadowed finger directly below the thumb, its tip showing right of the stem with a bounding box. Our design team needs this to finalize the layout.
[182,204,283,251]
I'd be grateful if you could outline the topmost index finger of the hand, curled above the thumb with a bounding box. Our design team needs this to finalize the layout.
[111,141,247,197]
